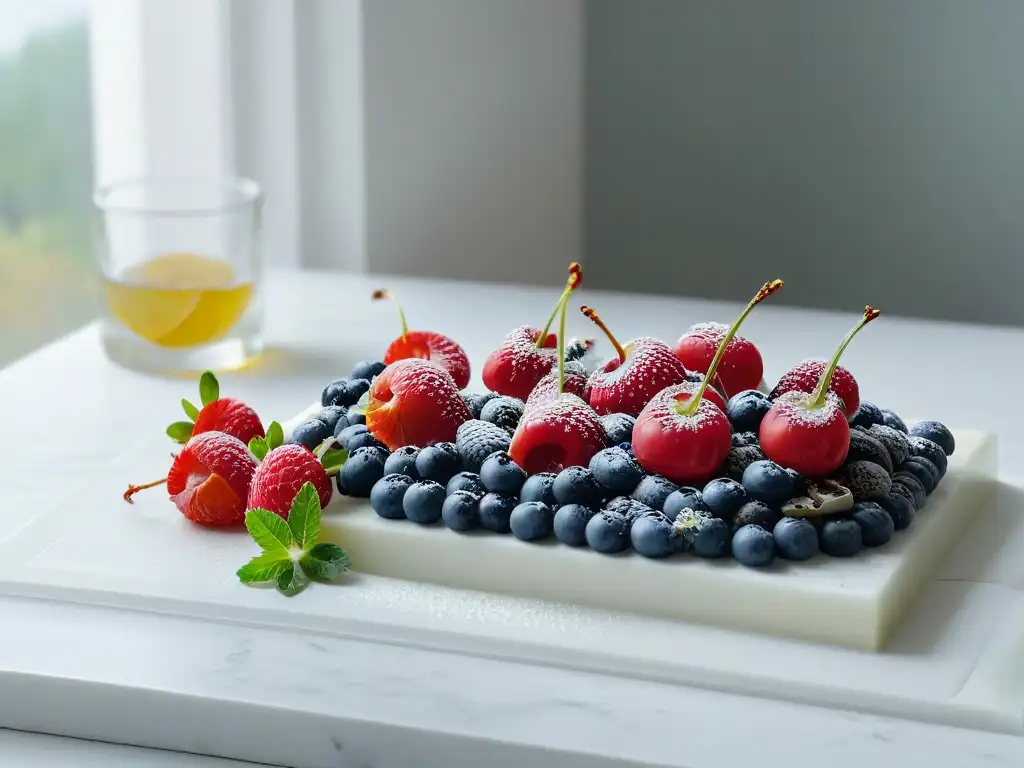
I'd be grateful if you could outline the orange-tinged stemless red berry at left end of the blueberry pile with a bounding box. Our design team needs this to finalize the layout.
[366,358,472,451]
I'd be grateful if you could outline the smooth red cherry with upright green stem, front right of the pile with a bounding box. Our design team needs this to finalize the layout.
[758,306,880,477]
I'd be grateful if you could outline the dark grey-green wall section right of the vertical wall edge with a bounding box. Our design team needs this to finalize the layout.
[585,0,1024,325]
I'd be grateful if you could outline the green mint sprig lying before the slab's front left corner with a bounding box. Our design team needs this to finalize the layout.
[237,482,351,597]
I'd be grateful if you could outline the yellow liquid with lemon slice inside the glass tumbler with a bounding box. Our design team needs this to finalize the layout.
[103,253,253,347]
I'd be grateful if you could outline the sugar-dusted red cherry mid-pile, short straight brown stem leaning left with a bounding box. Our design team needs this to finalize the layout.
[580,306,686,416]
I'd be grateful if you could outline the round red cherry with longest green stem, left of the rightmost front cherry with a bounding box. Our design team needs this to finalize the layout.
[633,280,782,485]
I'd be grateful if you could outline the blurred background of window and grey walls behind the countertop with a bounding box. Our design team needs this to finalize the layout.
[0,0,1024,366]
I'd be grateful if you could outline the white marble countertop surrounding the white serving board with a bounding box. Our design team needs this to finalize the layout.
[0,266,1024,768]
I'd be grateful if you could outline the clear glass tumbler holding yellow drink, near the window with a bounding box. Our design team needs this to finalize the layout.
[94,178,264,375]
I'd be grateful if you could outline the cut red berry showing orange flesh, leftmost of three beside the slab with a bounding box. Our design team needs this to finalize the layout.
[164,432,256,525]
